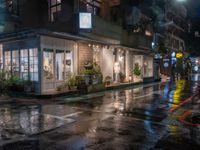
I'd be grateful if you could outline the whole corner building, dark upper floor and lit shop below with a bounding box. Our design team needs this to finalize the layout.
[0,0,155,94]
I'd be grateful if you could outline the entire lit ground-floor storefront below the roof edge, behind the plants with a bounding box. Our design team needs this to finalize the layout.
[0,29,153,94]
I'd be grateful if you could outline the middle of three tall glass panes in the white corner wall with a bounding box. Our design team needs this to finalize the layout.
[55,50,64,80]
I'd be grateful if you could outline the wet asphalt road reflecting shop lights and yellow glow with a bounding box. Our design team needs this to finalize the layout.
[0,80,200,150]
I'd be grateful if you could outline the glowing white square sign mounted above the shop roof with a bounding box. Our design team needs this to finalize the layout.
[79,13,92,29]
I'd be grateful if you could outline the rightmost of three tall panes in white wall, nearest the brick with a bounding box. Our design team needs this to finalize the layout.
[65,51,73,77]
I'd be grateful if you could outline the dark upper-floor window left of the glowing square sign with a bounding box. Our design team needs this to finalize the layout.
[48,0,61,22]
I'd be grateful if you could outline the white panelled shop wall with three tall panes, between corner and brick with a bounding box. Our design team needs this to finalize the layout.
[40,36,77,92]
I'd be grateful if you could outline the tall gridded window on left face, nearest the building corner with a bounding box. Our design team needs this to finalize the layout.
[29,48,38,81]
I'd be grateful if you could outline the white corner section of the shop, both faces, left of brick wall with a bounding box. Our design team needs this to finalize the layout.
[0,32,77,93]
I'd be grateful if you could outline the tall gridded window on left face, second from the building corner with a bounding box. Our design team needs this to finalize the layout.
[20,49,29,80]
